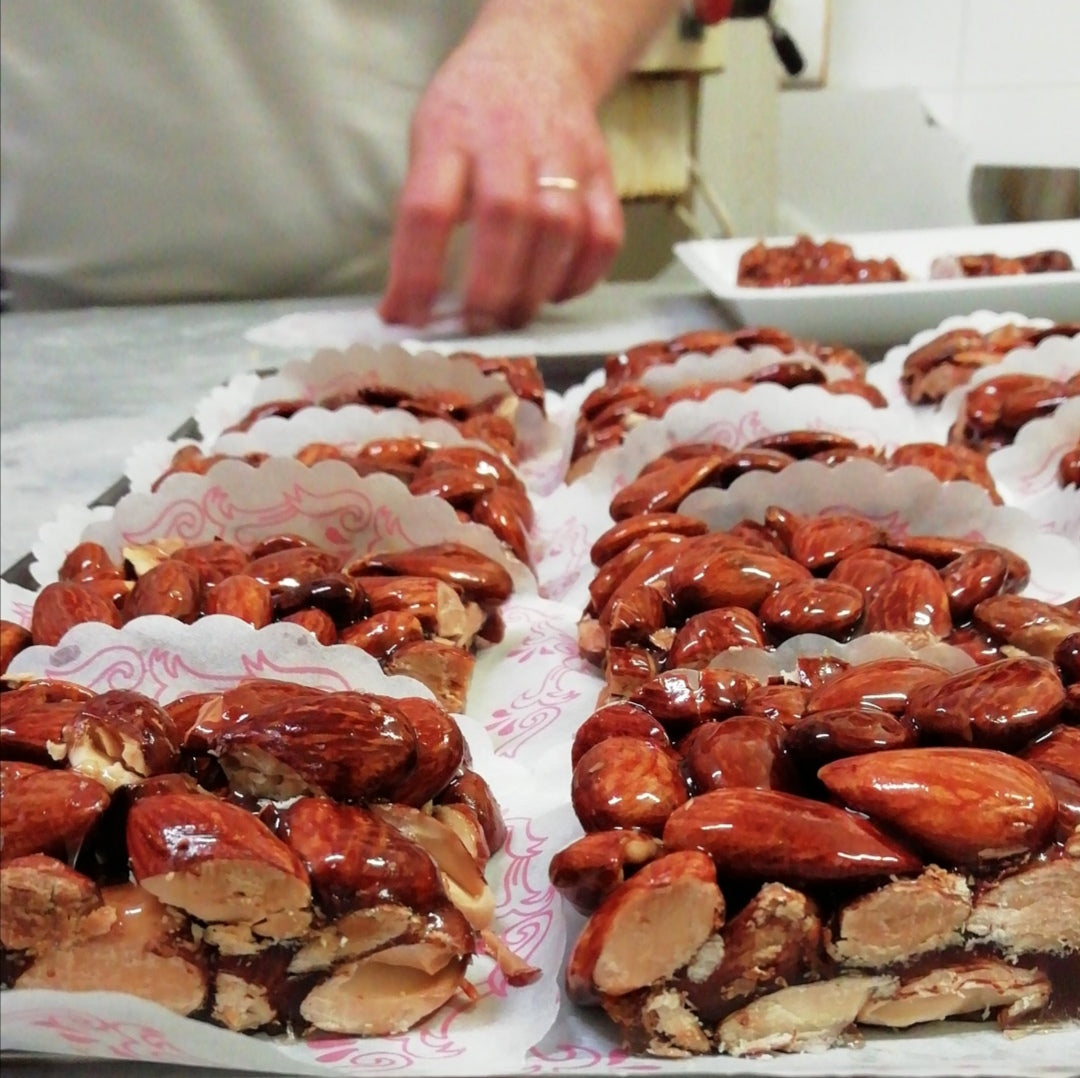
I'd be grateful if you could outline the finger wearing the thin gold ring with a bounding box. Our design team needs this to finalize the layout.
[503,170,588,324]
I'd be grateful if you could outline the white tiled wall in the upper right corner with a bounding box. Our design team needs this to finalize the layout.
[827,0,1080,167]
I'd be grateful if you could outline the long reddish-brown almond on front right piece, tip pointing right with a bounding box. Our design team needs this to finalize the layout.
[662,786,922,884]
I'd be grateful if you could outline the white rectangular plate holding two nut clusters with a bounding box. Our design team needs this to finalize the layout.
[675,220,1080,346]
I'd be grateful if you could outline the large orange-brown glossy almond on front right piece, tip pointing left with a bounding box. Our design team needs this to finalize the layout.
[818,749,1056,867]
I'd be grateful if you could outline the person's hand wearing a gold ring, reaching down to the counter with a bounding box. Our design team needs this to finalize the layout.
[379,13,623,333]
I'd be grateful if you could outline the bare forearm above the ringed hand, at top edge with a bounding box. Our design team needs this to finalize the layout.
[469,0,683,105]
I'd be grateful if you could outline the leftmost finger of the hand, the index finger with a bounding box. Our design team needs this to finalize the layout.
[379,146,469,325]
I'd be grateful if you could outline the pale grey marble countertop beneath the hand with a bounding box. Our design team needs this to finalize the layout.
[0,272,726,570]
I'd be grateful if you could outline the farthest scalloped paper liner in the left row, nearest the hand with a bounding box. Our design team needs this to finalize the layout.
[194,345,559,473]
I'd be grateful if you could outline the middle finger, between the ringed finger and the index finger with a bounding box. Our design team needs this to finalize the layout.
[464,153,537,333]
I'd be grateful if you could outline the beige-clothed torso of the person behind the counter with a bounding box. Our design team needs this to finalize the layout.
[0,0,477,302]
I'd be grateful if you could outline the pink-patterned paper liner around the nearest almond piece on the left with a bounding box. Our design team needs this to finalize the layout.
[2,616,568,1075]
